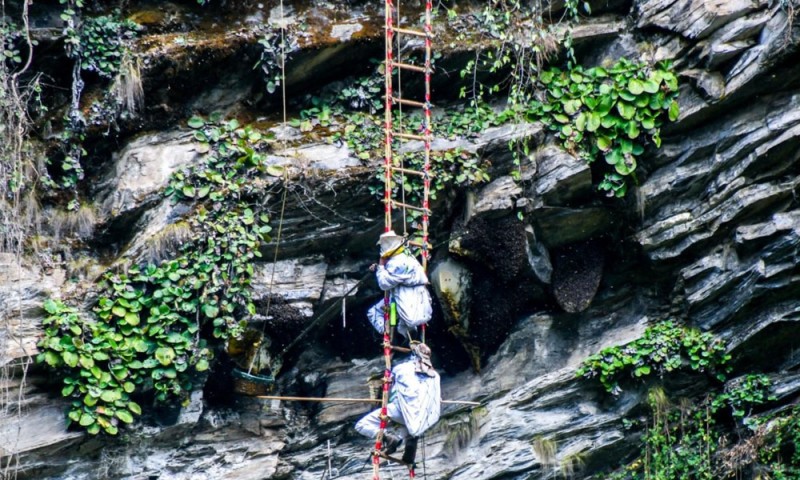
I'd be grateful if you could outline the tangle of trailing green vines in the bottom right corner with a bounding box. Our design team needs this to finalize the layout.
[599,375,780,480]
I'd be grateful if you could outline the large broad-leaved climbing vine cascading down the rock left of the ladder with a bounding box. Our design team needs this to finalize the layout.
[38,117,282,435]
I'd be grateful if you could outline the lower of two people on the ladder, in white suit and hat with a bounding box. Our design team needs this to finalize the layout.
[355,343,442,465]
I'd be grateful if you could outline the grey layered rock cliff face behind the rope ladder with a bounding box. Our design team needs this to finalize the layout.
[0,0,800,479]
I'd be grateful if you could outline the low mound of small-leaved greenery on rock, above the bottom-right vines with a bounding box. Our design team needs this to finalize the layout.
[576,321,730,395]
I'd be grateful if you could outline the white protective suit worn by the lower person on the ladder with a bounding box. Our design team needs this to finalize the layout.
[355,360,442,438]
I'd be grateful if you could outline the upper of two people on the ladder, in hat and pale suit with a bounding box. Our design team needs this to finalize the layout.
[367,230,433,340]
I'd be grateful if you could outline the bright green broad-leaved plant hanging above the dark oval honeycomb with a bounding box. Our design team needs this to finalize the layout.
[526,58,679,197]
